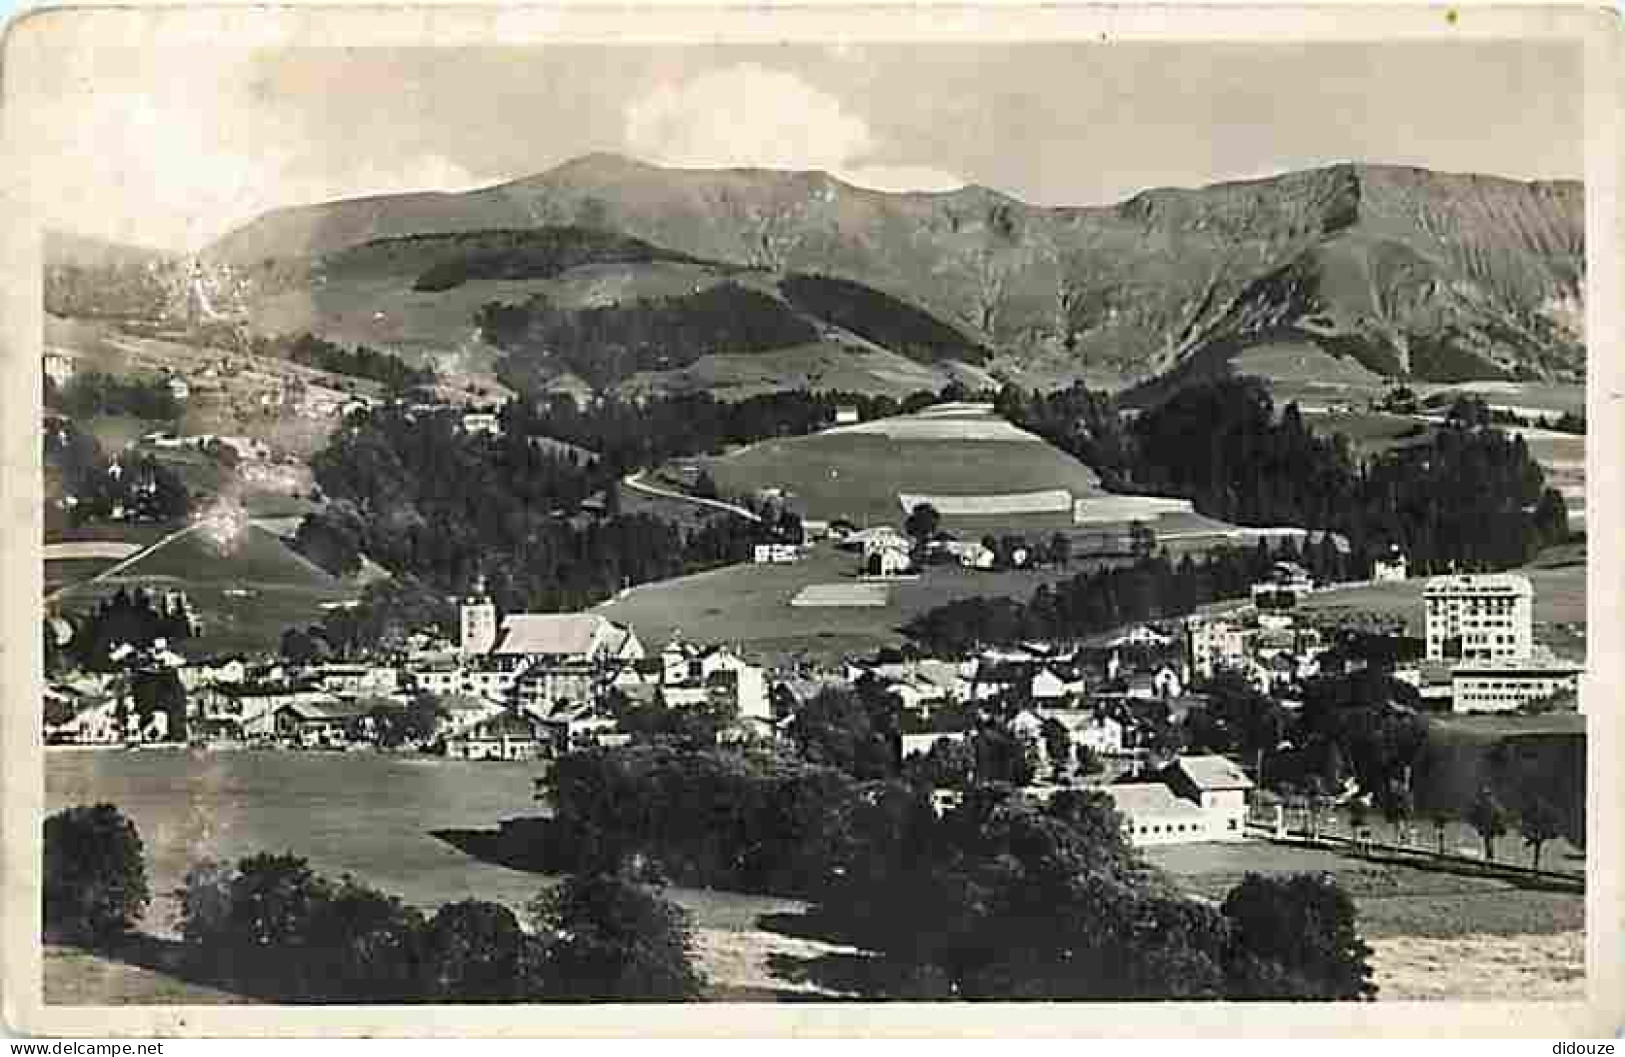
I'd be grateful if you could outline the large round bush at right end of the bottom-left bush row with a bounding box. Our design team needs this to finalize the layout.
[530,873,705,1002]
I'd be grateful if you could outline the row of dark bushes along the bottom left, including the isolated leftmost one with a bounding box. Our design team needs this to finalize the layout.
[42,803,707,1003]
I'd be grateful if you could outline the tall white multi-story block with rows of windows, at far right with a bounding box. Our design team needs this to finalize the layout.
[1422,572,1534,660]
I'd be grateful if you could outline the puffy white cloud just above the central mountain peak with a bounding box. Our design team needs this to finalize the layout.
[626,63,964,190]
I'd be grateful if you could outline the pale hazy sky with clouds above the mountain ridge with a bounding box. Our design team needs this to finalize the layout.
[15,42,1584,250]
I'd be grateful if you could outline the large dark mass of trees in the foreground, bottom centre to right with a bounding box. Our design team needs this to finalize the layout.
[551,746,1375,1000]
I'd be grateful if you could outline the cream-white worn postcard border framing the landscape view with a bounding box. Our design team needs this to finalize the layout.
[0,0,1625,1037]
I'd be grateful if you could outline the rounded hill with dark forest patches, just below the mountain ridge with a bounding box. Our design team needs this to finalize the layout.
[217,224,988,395]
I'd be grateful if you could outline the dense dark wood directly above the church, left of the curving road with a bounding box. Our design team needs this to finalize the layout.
[296,396,759,610]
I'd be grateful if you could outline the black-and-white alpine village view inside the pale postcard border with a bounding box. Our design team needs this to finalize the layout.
[7,8,1619,1024]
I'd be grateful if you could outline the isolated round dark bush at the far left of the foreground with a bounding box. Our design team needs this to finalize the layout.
[42,803,151,943]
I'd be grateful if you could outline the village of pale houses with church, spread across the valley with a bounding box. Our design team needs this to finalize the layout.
[46,510,1580,846]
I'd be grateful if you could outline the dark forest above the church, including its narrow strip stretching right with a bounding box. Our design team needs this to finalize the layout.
[296,390,952,610]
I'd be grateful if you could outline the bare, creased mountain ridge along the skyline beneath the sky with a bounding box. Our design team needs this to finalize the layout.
[208,154,1584,388]
